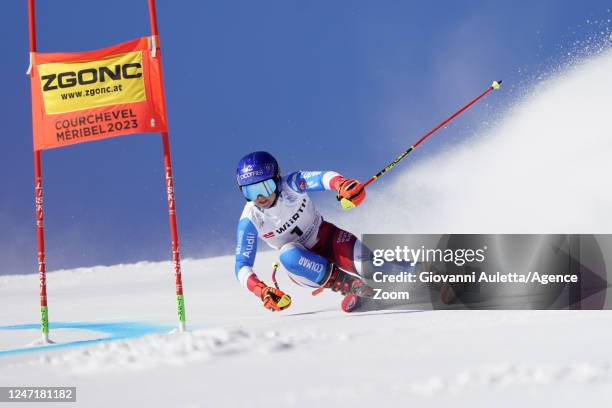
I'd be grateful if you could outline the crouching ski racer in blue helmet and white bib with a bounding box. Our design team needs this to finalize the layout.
[235,151,372,312]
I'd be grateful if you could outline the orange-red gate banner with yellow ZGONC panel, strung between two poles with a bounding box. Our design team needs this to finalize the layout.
[31,37,167,150]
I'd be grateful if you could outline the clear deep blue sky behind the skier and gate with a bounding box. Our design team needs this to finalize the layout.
[0,0,612,274]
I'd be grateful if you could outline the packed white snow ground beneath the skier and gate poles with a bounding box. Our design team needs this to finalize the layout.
[0,252,612,407]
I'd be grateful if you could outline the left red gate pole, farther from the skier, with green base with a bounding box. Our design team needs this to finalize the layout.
[28,0,52,344]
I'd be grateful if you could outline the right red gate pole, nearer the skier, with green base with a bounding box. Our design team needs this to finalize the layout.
[149,0,186,332]
